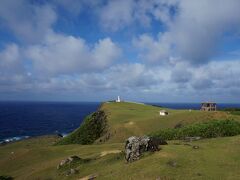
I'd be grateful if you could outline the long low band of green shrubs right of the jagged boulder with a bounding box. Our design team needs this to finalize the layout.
[151,120,240,140]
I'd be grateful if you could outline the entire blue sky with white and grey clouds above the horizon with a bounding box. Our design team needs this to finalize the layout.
[0,0,240,103]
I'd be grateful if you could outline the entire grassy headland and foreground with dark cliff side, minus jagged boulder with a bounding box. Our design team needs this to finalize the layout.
[0,102,240,180]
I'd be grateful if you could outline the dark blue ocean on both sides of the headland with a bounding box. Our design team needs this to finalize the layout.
[0,102,240,142]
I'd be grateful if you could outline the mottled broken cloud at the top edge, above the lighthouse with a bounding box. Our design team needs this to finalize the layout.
[98,0,178,31]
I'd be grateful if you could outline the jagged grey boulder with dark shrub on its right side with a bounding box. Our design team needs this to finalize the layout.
[125,136,167,162]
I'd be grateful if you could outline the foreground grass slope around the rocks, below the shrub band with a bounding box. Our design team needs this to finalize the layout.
[0,136,240,179]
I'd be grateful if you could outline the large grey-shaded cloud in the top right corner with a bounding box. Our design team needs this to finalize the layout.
[170,0,240,63]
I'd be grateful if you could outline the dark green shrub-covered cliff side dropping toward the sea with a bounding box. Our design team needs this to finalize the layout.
[57,110,107,145]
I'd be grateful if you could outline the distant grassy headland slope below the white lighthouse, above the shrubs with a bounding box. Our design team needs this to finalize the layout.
[99,103,236,143]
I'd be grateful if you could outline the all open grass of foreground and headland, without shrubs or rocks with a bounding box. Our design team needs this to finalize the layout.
[0,103,240,180]
